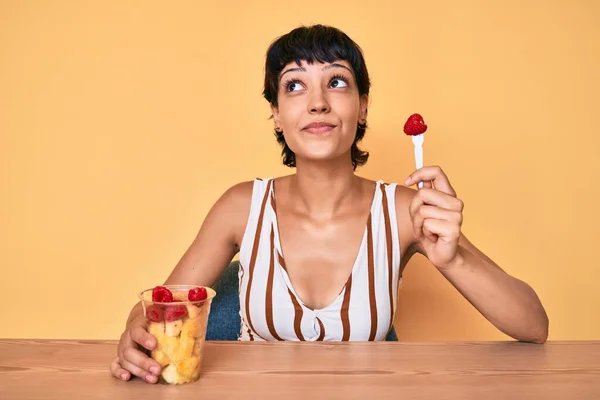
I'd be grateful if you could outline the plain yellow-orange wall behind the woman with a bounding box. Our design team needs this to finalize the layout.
[0,0,600,341]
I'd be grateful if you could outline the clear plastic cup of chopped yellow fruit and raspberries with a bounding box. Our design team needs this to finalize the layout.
[139,285,217,384]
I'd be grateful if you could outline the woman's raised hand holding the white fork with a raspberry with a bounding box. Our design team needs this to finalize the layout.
[404,166,464,269]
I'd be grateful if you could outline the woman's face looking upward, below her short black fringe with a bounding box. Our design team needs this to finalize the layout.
[272,61,368,163]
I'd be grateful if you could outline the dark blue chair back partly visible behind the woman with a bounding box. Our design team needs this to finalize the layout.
[206,261,398,341]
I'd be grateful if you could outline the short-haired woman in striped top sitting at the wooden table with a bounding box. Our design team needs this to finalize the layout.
[111,25,548,383]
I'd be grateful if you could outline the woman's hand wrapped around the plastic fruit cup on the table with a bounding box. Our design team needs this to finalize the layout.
[110,316,161,383]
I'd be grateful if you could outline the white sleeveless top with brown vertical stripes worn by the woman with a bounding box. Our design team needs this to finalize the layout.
[238,178,402,341]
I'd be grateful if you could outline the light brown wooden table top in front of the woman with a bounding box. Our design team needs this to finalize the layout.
[0,340,600,400]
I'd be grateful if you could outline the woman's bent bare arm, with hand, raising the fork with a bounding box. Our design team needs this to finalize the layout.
[396,167,548,343]
